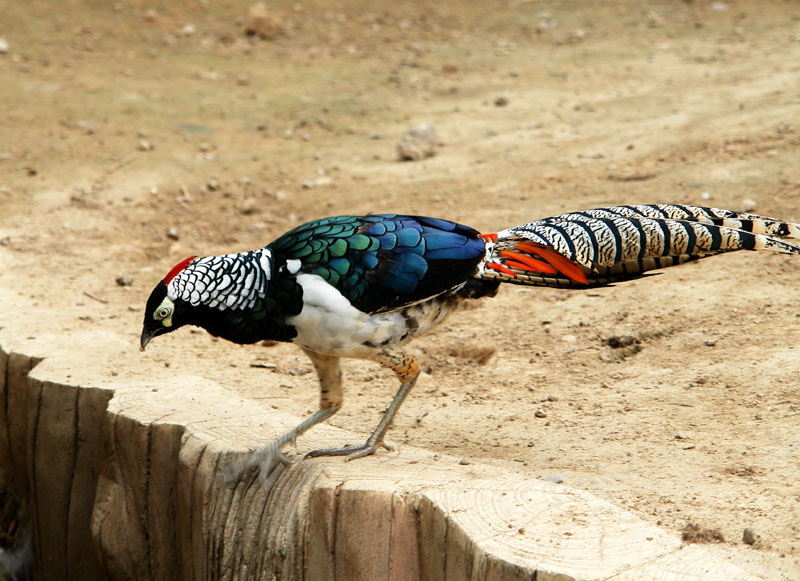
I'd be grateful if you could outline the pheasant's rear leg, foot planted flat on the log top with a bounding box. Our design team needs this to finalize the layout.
[306,351,419,460]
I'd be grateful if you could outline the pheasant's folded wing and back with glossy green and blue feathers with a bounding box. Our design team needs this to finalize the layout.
[269,214,485,313]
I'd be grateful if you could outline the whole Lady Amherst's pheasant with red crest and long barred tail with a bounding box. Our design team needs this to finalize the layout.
[141,204,800,477]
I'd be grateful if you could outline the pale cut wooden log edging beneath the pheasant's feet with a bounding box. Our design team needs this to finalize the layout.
[0,342,764,580]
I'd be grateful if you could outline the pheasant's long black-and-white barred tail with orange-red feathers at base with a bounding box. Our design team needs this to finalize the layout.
[478,204,800,288]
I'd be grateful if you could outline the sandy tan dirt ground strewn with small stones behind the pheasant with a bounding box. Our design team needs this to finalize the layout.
[0,0,800,579]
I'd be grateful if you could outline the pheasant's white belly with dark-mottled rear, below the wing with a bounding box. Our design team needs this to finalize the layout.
[286,274,456,359]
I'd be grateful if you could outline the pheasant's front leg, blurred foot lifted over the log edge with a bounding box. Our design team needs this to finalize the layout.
[231,349,343,480]
